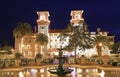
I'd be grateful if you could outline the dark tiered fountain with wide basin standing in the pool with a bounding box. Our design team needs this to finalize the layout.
[48,48,73,77]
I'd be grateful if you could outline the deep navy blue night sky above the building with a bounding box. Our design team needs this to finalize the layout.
[0,0,120,45]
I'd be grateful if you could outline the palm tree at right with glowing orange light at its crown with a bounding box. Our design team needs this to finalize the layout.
[94,33,110,57]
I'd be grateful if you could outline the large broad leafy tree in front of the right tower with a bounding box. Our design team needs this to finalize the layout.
[60,21,94,61]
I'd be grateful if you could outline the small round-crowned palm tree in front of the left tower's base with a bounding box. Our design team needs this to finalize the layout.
[35,33,48,53]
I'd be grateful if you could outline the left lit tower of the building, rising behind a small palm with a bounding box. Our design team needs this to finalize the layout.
[37,11,50,35]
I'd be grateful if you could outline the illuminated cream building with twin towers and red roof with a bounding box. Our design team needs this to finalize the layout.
[15,10,114,58]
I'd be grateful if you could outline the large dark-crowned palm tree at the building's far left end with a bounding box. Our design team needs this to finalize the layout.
[13,22,33,52]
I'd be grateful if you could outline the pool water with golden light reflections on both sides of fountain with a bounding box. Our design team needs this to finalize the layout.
[0,67,120,77]
